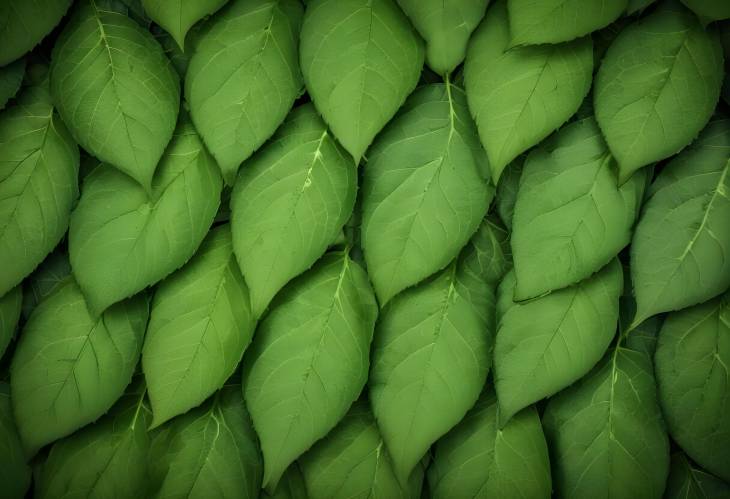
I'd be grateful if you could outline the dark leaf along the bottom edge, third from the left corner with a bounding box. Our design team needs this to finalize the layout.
[151,385,261,499]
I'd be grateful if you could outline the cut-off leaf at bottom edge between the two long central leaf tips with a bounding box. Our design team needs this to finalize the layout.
[300,401,423,499]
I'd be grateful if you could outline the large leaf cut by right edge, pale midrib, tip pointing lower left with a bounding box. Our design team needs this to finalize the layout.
[631,119,730,325]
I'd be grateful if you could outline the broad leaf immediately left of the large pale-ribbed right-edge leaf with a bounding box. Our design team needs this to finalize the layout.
[511,118,648,301]
